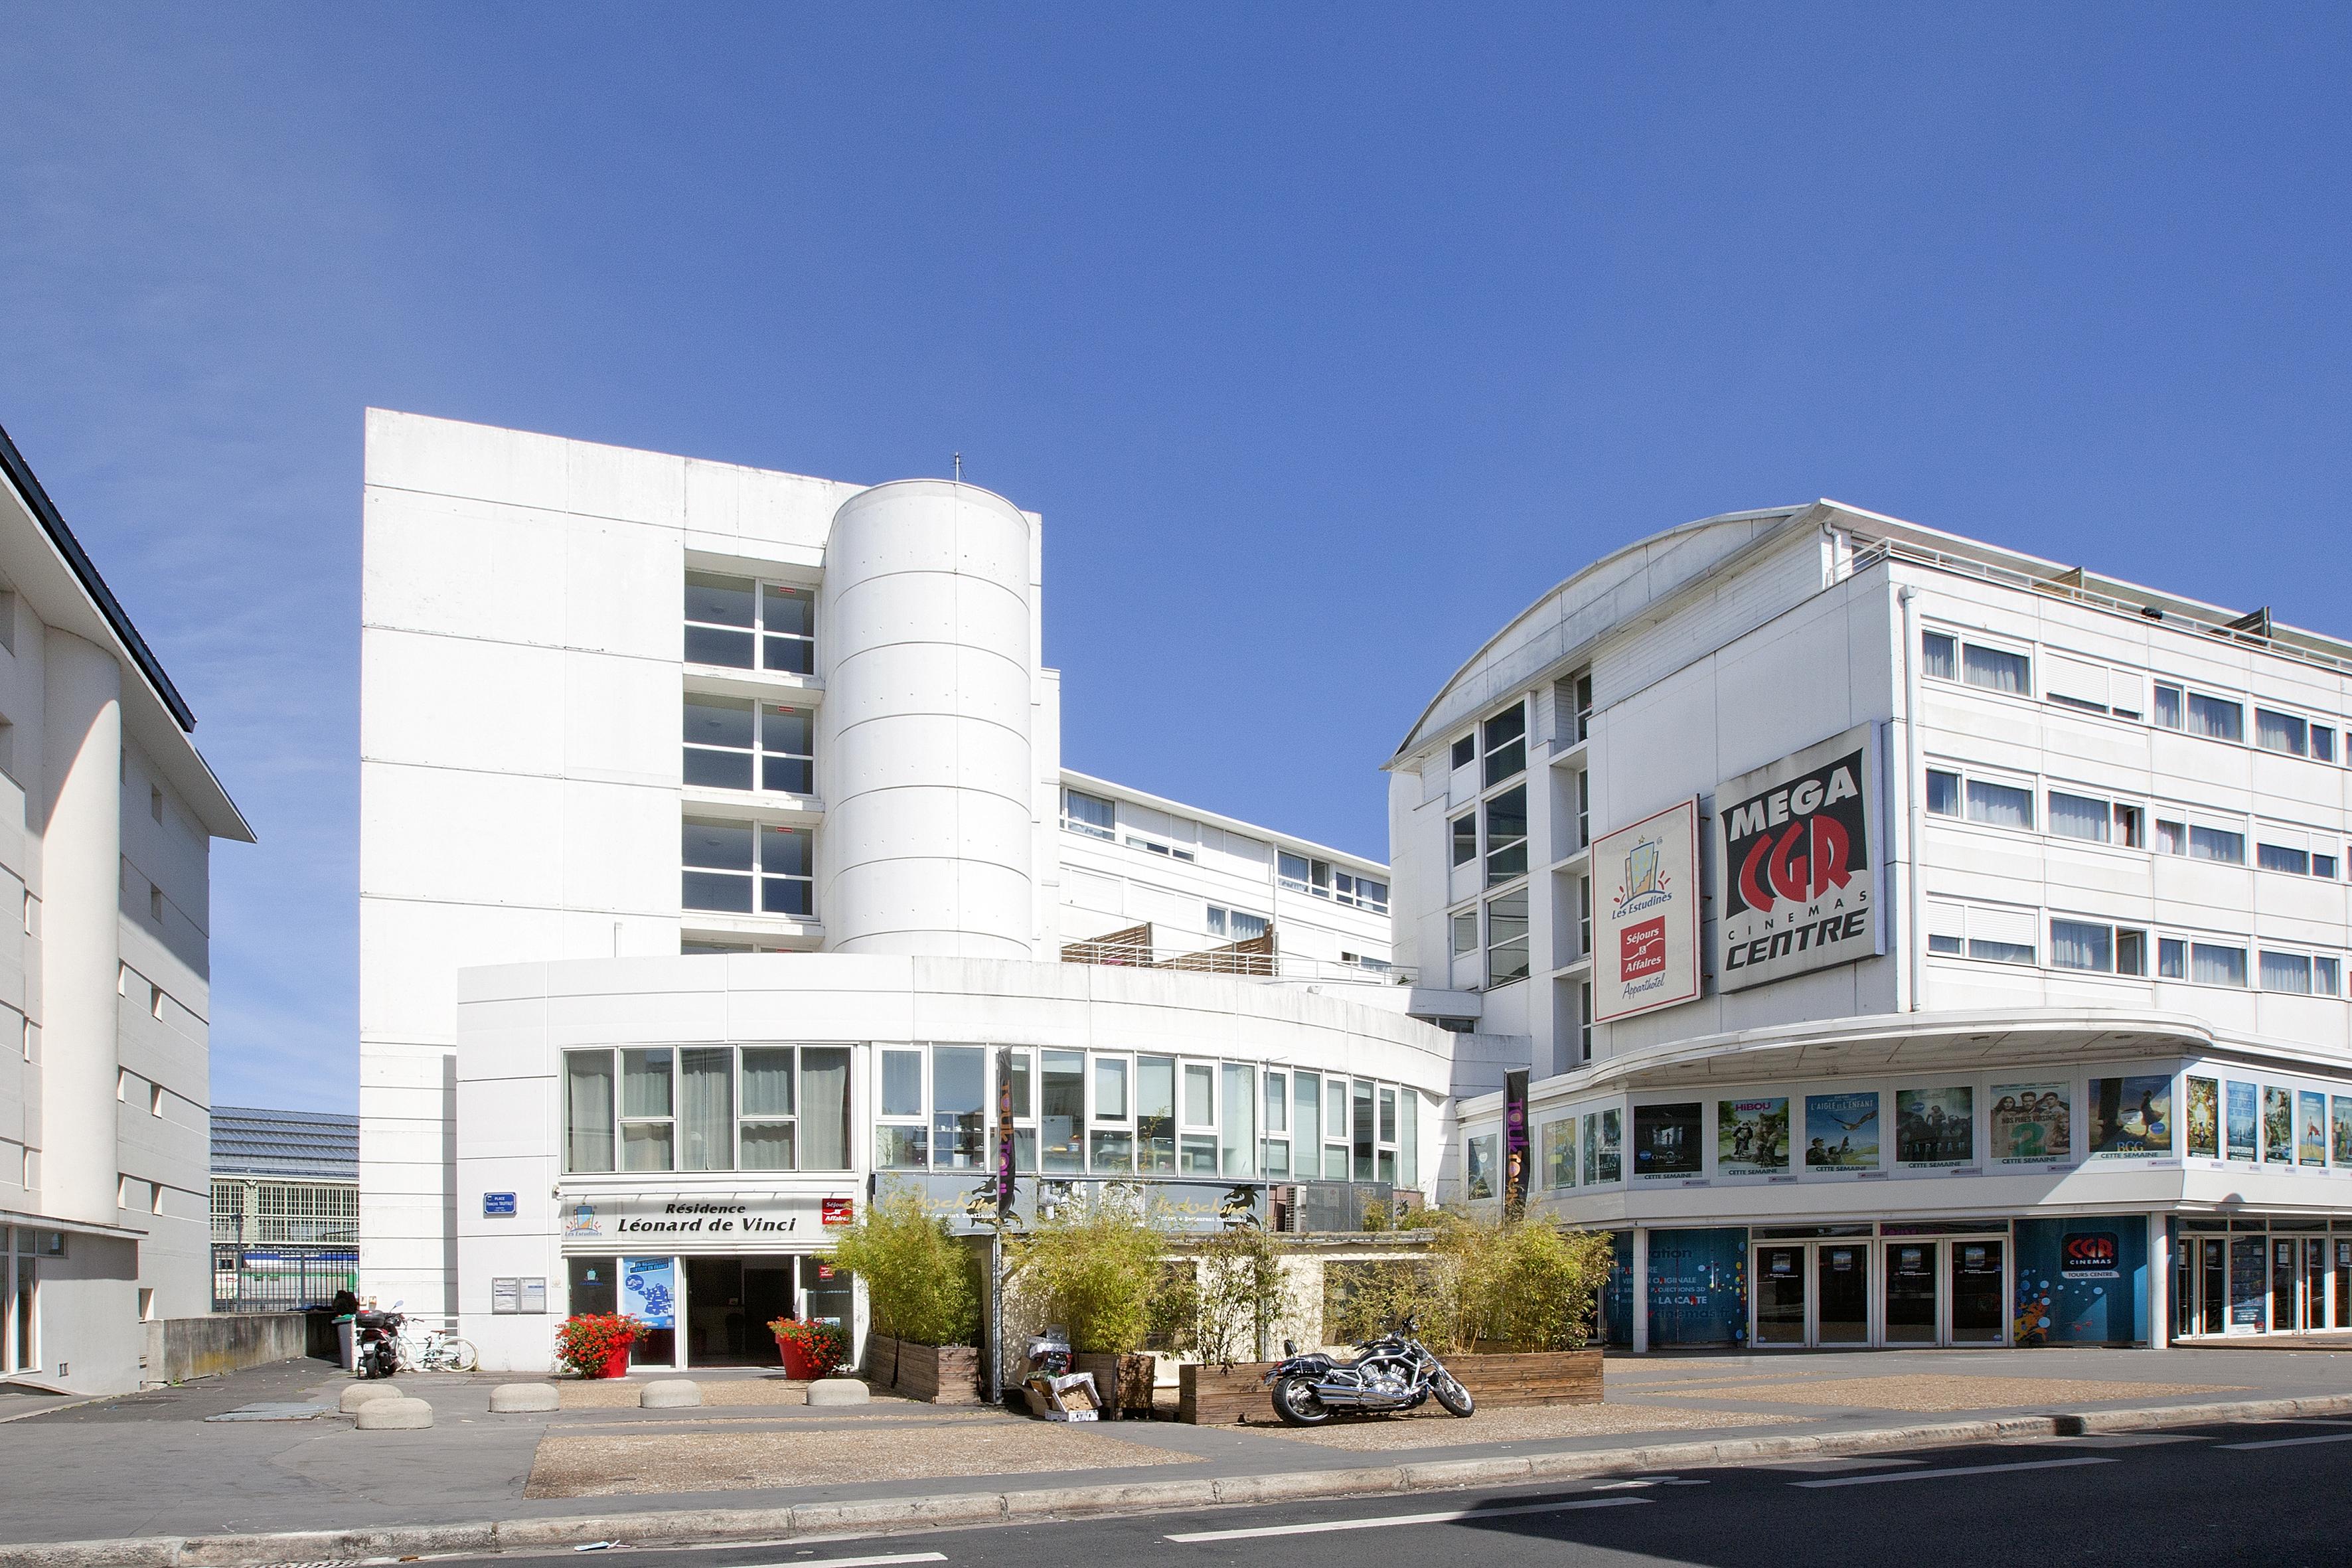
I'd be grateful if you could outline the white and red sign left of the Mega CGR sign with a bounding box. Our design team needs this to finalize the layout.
[1593,799,1698,1022]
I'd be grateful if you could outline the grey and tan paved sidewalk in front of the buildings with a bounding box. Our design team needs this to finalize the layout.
[13,1350,2352,1568]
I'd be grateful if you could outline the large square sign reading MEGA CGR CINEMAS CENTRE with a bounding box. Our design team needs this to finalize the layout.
[1715,724,1886,992]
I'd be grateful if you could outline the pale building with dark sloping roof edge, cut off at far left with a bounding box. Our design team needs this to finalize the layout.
[0,420,254,1394]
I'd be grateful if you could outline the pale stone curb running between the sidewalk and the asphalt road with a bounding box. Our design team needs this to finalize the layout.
[18,1394,2352,1568]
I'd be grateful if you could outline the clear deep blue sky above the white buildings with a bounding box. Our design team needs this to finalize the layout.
[0,0,2352,1107]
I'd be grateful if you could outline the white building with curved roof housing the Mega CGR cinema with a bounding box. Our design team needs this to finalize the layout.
[1387,501,2352,1350]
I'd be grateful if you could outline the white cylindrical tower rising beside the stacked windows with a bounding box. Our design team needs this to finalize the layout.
[816,479,1037,959]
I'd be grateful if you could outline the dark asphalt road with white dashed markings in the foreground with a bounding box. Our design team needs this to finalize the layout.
[428,1420,2352,1568]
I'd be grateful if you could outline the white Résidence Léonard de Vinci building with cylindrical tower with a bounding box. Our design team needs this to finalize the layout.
[360,412,1465,1368]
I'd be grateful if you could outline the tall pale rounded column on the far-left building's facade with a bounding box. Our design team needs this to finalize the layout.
[40,630,122,1225]
